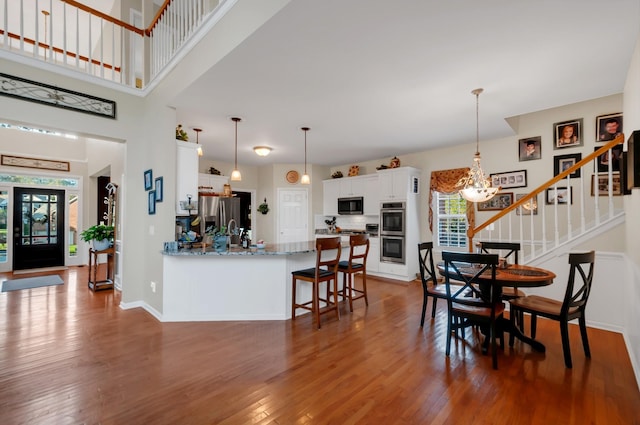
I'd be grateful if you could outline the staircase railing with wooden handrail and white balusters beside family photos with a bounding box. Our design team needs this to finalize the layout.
[467,135,626,262]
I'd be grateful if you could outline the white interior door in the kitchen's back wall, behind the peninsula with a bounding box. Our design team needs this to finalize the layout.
[278,189,309,243]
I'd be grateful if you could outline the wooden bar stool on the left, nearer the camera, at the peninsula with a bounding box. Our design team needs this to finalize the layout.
[291,236,342,329]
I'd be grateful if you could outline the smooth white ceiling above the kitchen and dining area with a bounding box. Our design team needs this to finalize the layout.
[174,0,640,165]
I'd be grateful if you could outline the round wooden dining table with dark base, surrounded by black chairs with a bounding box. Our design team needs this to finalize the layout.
[437,262,556,353]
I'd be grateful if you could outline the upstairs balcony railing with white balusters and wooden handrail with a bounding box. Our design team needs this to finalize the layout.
[0,0,230,88]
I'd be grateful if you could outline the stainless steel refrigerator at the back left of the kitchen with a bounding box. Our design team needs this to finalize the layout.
[198,194,245,244]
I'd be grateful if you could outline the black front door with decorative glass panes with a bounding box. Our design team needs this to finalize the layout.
[13,187,65,270]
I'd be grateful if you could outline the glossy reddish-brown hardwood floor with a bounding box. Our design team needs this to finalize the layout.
[0,267,640,425]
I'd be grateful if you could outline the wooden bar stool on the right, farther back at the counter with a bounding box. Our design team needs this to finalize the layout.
[338,233,369,312]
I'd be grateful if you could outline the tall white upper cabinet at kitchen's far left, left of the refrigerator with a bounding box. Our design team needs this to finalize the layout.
[176,140,198,215]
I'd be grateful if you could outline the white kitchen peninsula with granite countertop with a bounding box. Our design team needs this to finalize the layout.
[160,241,330,322]
